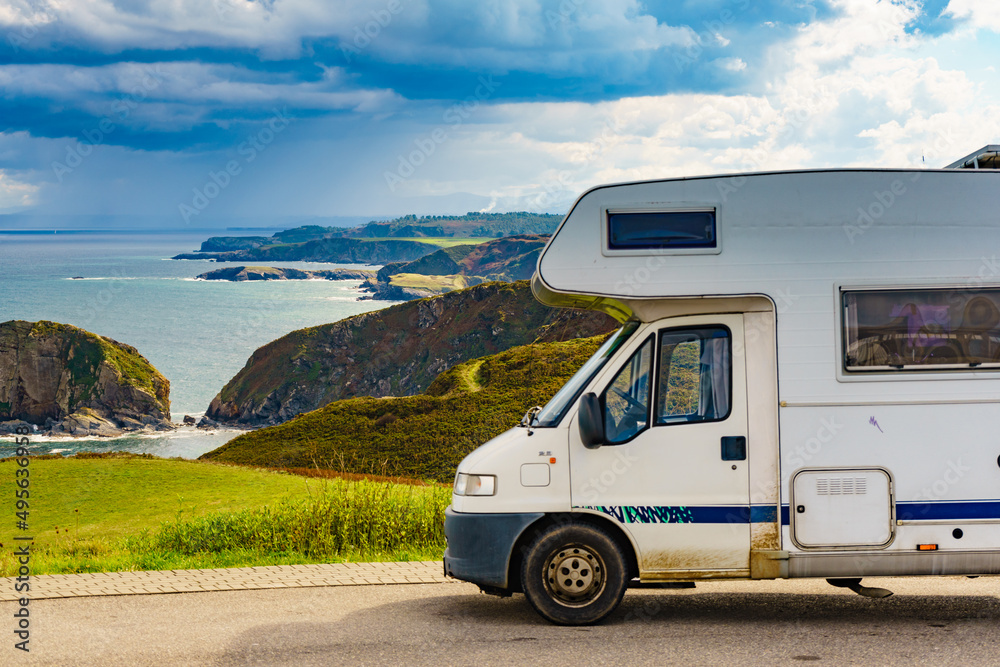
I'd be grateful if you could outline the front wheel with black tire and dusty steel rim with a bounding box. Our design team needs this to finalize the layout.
[521,524,628,625]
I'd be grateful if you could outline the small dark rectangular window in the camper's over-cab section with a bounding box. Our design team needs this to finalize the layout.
[608,209,717,250]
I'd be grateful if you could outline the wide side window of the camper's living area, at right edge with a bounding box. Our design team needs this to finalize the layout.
[843,289,1000,372]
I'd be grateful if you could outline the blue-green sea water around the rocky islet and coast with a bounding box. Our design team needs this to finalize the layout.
[0,229,396,458]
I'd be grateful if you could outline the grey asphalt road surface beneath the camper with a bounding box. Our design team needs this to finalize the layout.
[0,577,1000,666]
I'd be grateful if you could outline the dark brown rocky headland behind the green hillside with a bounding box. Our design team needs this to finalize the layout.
[207,281,617,426]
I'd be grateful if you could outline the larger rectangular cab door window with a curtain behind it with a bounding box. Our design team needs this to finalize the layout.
[656,327,732,426]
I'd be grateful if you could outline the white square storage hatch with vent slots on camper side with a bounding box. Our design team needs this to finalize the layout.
[789,468,893,549]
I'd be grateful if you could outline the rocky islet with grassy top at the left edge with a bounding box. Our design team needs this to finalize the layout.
[0,321,173,435]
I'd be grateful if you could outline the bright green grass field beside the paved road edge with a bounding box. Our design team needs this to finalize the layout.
[0,455,450,576]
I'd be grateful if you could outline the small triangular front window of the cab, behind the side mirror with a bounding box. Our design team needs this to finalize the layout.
[601,337,653,443]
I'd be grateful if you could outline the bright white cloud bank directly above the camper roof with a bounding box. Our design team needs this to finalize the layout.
[374,0,1000,209]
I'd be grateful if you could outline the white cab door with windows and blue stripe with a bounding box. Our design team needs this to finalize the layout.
[570,314,750,579]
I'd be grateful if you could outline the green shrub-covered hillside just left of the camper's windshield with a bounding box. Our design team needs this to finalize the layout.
[201,336,603,482]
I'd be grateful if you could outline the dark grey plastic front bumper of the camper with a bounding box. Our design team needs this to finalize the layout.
[444,507,545,589]
